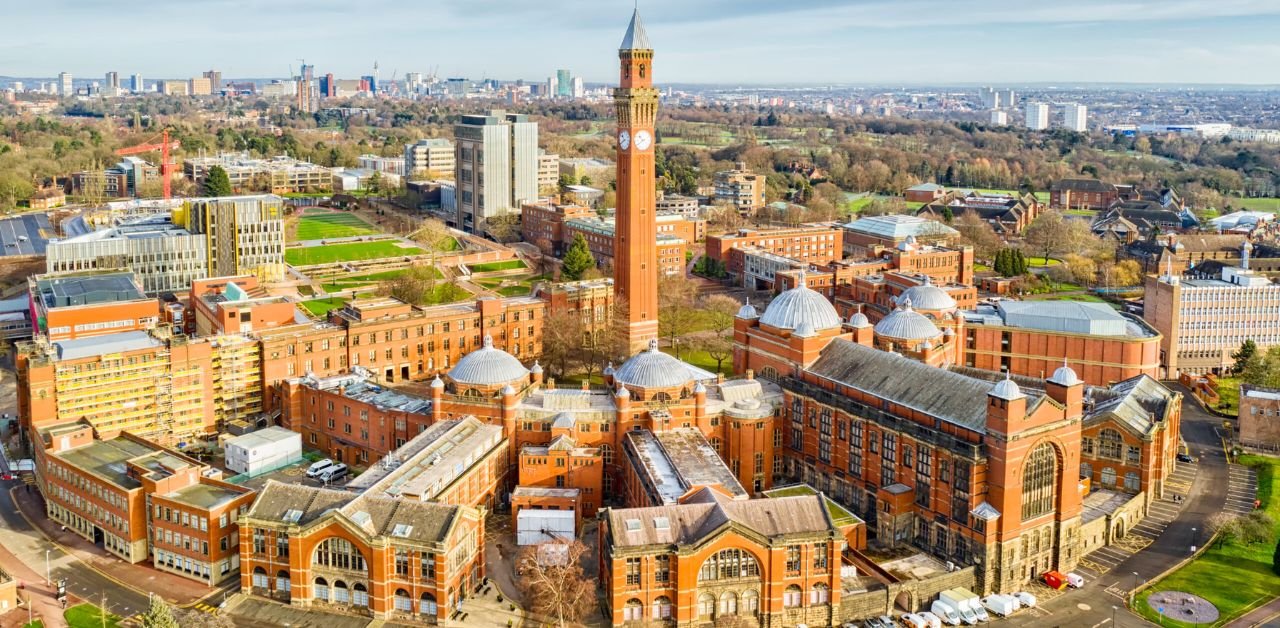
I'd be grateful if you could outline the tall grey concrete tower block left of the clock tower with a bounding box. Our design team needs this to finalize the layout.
[453,111,539,233]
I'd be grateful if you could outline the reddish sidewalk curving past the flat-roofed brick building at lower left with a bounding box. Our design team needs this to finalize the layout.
[13,486,221,606]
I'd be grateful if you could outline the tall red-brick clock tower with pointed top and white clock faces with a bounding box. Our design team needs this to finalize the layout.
[613,9,658,352]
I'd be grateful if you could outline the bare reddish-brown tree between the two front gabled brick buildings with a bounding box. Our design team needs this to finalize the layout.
[517,540,595,627]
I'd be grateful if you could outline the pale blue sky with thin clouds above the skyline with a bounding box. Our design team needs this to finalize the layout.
[0,0,1280,84]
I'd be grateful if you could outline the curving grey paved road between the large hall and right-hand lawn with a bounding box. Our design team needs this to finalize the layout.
[1001,382,1230,627]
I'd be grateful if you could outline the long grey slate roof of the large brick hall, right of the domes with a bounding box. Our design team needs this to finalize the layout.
[808,339,1037,432]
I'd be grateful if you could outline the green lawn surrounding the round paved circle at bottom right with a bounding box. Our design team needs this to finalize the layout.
[1137,455,1280,627]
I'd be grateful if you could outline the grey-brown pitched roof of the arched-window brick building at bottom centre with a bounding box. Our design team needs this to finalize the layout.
[608,489,836,547]
